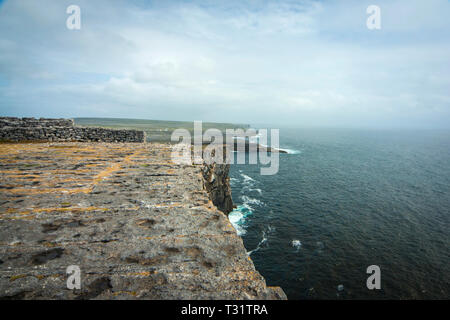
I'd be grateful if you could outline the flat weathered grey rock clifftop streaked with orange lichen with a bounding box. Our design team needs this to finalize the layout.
[0,143,286,299]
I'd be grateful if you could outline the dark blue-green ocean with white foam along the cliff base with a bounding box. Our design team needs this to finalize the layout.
[229,129,450,299]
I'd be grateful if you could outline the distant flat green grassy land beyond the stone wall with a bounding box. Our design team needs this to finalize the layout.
[74,118,249,142]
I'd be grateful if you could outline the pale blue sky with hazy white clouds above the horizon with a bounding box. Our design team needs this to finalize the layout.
[0,0,450,128]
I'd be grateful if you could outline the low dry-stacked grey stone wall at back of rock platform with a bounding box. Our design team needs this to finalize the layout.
[0,117,145,142]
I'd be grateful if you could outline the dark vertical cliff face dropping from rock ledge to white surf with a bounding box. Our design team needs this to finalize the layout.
[203,163,233,214]
